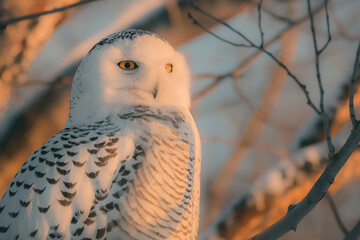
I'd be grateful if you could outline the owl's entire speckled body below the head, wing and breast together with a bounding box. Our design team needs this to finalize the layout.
[0,106,200,240]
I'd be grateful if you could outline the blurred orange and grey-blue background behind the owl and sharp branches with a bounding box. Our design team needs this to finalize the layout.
[0,0,360,240]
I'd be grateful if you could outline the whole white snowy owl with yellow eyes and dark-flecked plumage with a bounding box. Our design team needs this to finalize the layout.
[0,29,200,240]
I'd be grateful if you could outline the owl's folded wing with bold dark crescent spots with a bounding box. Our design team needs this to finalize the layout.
[0,118,134,239]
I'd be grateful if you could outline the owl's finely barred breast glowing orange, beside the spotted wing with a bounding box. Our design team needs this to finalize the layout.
[102,106,200,240]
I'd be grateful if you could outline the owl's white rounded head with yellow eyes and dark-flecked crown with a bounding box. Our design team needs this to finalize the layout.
[68,29,190,123]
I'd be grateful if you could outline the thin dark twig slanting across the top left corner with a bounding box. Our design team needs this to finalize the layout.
[0,0,99,30]
